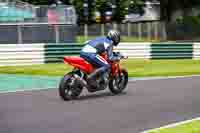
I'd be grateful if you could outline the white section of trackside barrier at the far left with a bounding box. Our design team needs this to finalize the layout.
[0,44,45,66]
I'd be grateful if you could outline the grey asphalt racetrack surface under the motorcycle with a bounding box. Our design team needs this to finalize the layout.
[0,77,200,133]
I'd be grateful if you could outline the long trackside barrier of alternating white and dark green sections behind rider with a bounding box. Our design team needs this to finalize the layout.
[0,43,200,66]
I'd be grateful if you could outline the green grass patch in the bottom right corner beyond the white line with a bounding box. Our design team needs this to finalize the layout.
[148,120,200,133]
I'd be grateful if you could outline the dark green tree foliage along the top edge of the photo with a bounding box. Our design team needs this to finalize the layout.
[22,0,200,22]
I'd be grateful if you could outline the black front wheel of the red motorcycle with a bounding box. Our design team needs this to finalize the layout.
[109,70,128,94]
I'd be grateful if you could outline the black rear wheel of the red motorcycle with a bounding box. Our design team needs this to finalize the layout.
[58,73,82,101]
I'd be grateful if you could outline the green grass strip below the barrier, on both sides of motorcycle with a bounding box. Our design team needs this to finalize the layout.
[0,59,200,77]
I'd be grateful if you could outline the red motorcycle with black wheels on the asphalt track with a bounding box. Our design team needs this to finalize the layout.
[59,52,128,100]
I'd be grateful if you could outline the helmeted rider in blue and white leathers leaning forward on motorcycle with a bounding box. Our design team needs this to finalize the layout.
[80,30,120,88]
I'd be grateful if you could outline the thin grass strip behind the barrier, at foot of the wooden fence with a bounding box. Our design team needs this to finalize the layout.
[76,36,160,43]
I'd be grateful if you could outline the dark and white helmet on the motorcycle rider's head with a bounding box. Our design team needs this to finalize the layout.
[107,30,120,46]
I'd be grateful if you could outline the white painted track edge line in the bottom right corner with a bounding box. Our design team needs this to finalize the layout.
[141,117,200,133]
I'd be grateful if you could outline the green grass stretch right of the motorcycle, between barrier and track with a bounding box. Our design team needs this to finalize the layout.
[124,59,200,77]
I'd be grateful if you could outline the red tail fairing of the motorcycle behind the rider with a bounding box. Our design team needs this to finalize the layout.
[64,56,94,73]
